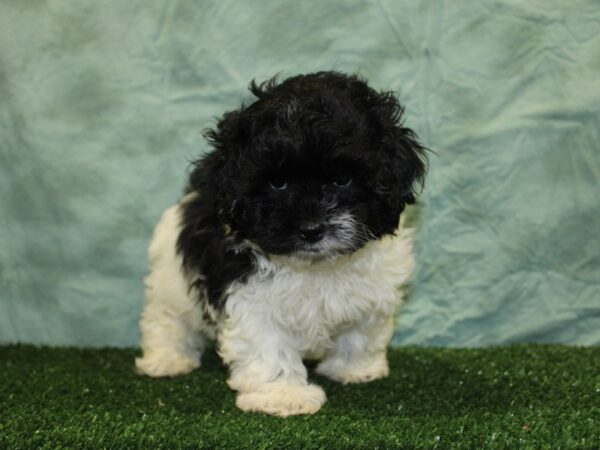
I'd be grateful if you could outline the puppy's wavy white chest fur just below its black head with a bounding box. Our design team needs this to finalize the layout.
[225,230,414,356]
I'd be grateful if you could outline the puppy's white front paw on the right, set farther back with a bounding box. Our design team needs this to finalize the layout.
[315,356,390,384]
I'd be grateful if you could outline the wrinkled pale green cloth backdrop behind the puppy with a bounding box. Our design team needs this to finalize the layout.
[0,0,600,346]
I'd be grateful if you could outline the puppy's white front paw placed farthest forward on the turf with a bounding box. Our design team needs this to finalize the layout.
[235,383,326,417]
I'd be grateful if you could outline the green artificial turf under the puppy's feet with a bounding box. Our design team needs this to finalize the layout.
[0,345,600,449]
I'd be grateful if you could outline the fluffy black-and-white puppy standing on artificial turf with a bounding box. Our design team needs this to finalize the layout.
[136,72,425,416]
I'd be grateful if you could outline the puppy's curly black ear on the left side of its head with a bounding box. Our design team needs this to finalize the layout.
[189,110,245,223]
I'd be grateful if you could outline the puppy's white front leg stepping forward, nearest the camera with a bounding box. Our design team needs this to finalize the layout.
[219,317,326,417]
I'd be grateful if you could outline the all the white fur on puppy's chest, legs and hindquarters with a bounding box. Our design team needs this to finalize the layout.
[136,199,414,416]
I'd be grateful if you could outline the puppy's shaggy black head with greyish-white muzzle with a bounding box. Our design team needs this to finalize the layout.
[191,72,425,259]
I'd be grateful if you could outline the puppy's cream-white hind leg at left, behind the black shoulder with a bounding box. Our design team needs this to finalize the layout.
[135,206,206,377]
